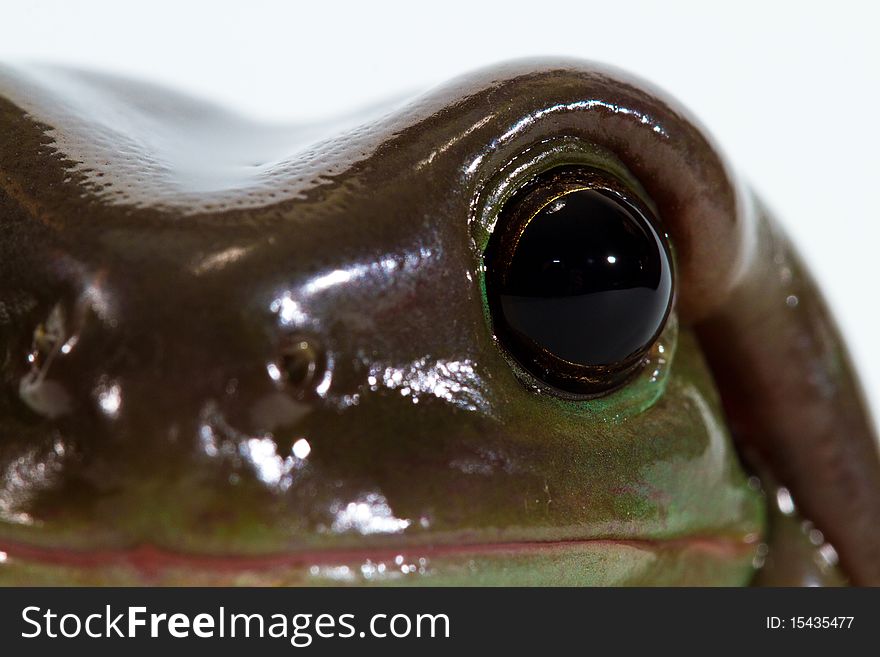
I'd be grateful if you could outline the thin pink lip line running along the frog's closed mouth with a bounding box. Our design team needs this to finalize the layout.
[0,536,754,574]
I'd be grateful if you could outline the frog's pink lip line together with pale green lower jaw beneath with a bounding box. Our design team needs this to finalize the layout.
[0,535,757,585]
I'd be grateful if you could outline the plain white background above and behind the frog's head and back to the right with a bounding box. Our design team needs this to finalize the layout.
[0,0,880,417]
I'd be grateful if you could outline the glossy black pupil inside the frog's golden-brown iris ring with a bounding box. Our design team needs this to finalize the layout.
[497,189,672,374]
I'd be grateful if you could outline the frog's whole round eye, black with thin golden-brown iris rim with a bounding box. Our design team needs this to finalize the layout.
[485,167,673,395]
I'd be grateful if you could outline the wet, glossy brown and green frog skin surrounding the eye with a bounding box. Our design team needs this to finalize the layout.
[0,61,880,585]
